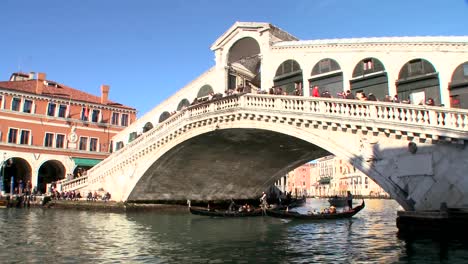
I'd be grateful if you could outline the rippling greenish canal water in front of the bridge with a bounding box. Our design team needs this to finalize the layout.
[0,199,468,263]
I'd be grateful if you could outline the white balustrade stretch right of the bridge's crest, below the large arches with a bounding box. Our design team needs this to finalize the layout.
[240,94,468,131]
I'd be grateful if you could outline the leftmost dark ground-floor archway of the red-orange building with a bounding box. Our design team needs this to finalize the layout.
[2,158,32,193]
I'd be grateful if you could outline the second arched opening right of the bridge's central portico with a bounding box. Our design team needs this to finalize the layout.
[309,58,343,97]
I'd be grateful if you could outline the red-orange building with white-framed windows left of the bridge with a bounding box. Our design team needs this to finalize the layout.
[0,73,136,192]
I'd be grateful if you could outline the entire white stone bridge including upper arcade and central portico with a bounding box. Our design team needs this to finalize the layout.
[62,23,468,209]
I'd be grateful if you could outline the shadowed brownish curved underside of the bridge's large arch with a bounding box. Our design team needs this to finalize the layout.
[128,128,330,201]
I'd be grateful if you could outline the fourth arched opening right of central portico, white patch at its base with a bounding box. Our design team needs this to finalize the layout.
[396,59,441,105]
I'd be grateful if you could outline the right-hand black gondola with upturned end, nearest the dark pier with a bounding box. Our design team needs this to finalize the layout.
[266,200,366,220]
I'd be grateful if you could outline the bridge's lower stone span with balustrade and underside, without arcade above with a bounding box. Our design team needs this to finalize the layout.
[62,94,468,210]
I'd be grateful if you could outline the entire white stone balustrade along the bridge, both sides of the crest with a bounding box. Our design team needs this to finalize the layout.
[63,94,468,192]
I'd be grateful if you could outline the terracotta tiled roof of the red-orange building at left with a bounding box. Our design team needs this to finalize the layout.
[0,80,136,110]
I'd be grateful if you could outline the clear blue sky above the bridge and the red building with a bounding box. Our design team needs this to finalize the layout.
[0,0,468,116]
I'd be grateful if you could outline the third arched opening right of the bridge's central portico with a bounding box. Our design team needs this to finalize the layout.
[350,58,389,101]
